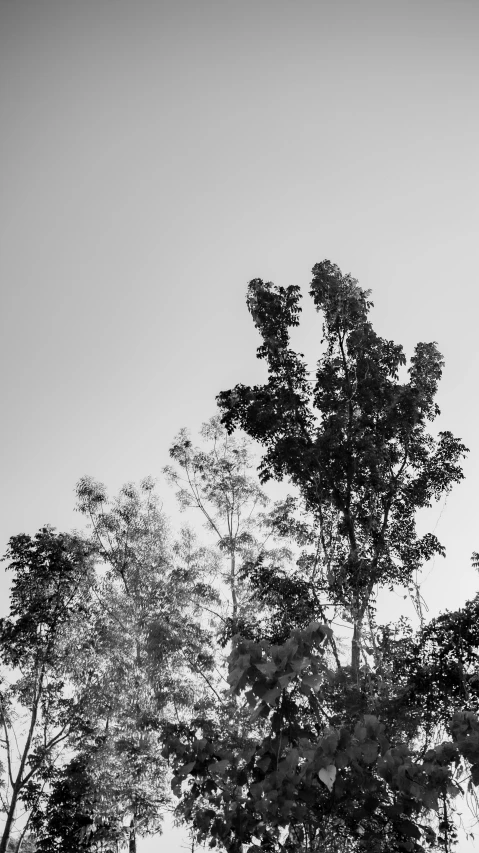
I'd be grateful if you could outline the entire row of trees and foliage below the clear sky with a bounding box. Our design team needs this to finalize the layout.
[0,261,479,853]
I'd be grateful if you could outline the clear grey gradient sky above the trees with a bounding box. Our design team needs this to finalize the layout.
[0,0,479,853]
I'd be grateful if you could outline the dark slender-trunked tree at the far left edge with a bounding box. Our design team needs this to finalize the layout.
[0,527,92,853]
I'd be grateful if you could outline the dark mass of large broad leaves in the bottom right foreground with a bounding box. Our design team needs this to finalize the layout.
[165,623,479,853]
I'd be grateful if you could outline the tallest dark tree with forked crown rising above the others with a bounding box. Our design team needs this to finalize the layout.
[218,261,466,673]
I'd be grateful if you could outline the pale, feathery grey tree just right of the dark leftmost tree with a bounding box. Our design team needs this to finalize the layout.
[27,478,216,853]
